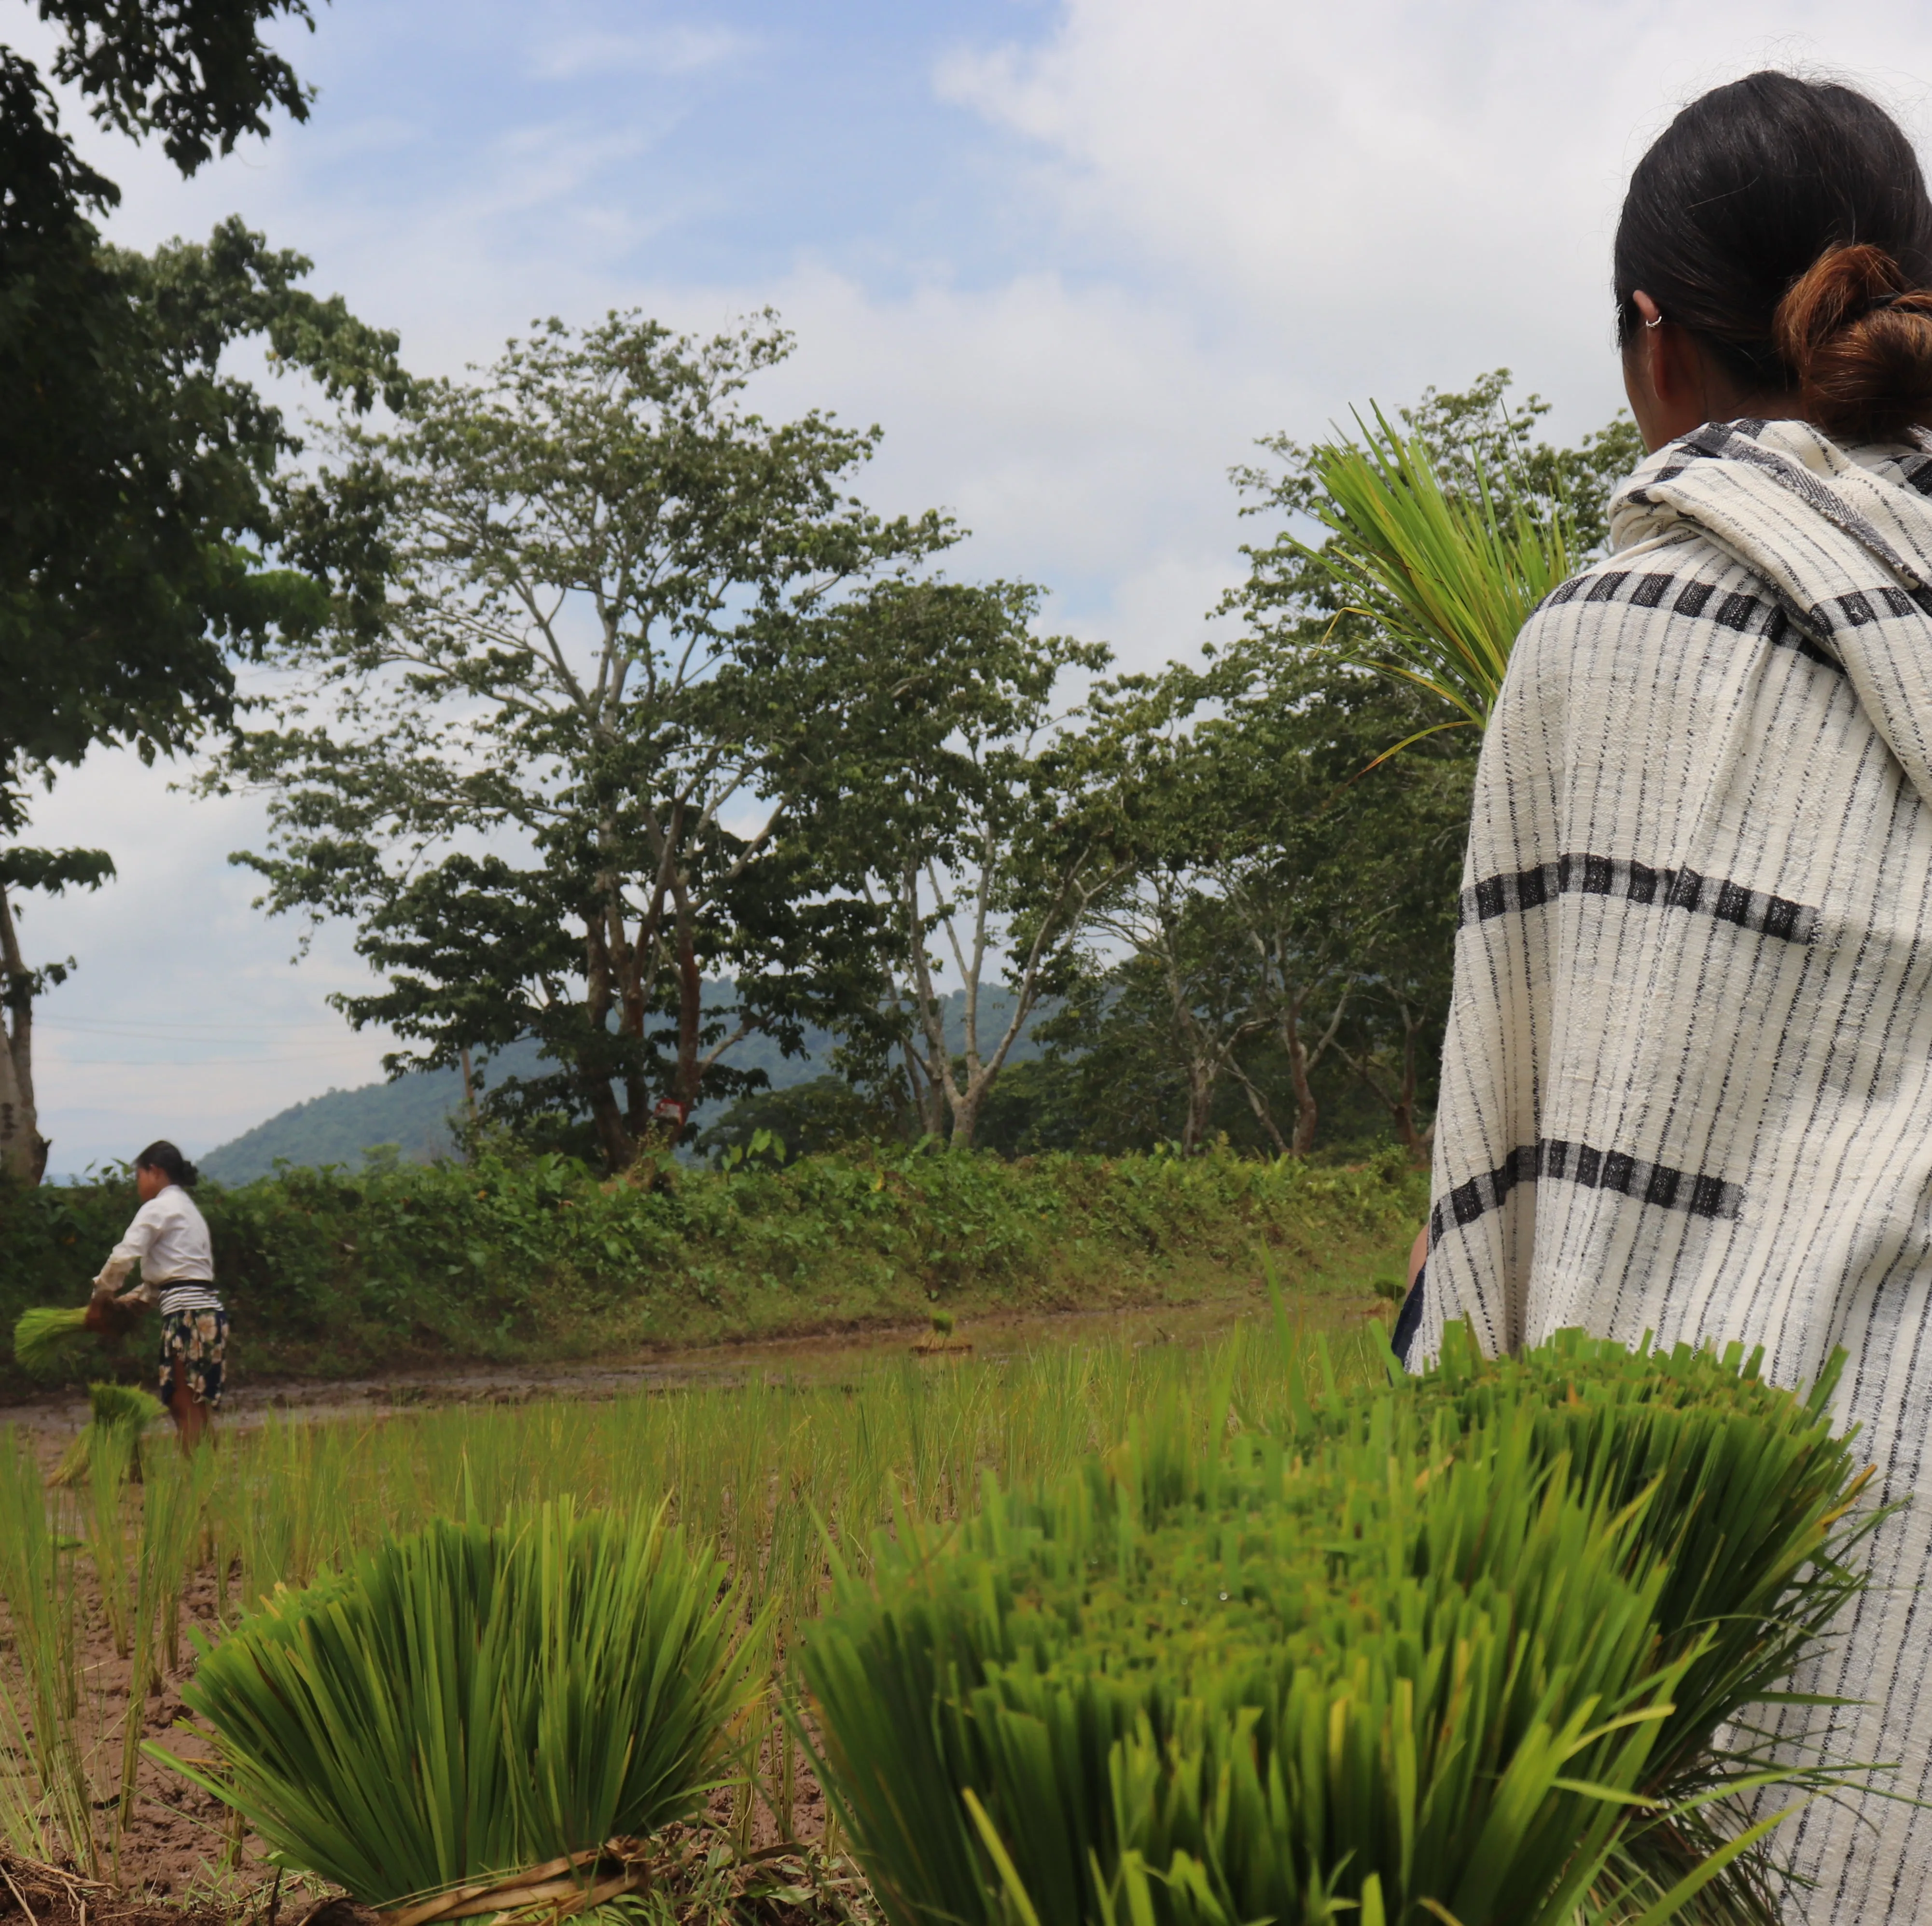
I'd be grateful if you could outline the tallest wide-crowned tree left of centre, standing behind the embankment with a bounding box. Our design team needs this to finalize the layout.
[216,315,950,1171]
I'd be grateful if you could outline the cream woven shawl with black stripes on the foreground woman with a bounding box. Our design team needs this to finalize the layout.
[1416,421,1932,1926]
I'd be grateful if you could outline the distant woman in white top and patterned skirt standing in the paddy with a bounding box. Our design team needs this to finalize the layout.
[95,1140,228,1451]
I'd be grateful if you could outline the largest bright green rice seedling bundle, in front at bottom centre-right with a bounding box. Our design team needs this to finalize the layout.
[802,1398,1708,1926]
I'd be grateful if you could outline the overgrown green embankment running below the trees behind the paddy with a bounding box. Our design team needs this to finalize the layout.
[0,1149,1426,1393]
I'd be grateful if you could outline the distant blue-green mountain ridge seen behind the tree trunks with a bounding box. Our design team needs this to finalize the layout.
[201,985,1040,1184]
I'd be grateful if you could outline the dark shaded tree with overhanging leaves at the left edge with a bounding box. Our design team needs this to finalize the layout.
[0,0,400,1178]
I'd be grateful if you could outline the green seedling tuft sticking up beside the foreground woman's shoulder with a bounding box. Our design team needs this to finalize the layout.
[1294,407,1574,740]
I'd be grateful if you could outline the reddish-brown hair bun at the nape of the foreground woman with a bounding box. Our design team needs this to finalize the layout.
[1774,241,1932,440]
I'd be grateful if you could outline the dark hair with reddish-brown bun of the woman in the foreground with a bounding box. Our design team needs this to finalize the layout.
[1615,73,1932,440]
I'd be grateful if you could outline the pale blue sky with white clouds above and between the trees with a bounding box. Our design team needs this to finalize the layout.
[0,0,1932,1171]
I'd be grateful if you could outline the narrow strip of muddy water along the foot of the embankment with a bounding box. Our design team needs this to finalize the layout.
[0,1292,1389,1433]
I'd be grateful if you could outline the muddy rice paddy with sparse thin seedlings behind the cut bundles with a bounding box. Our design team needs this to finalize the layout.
[0,1288,1389,1926]
